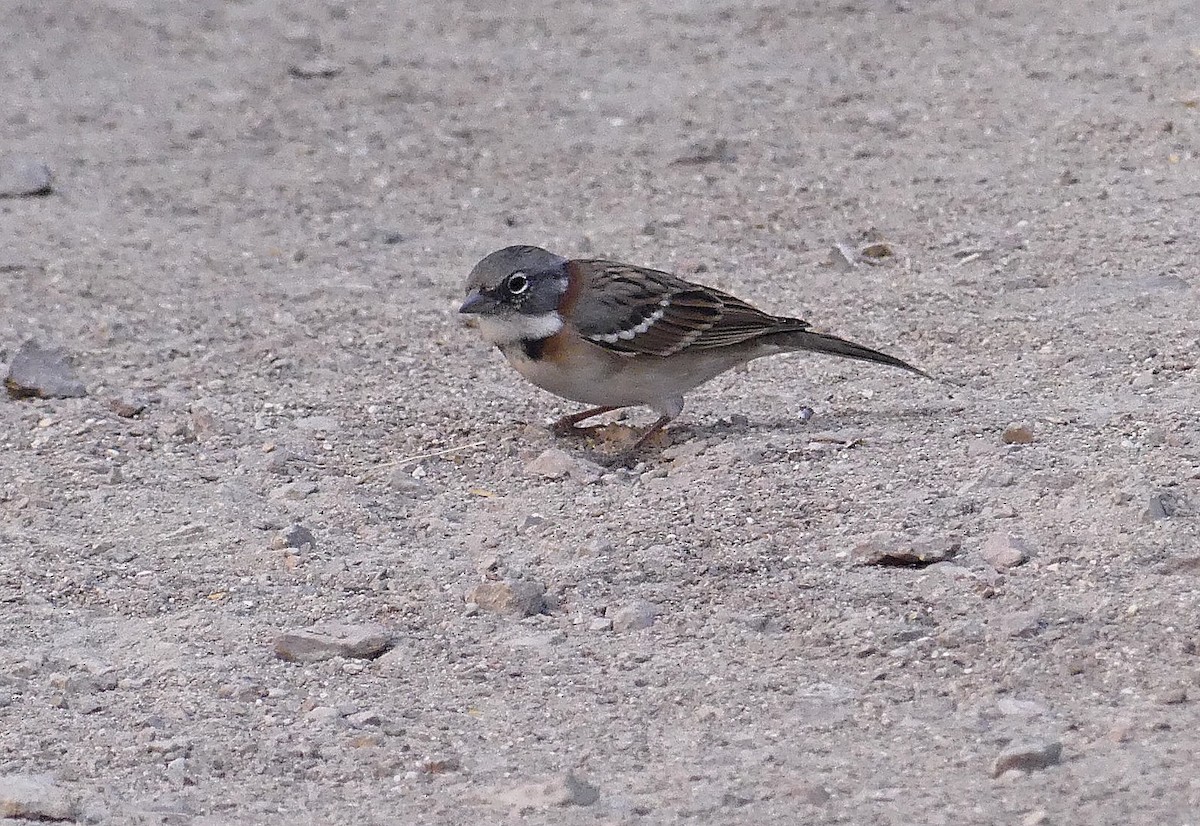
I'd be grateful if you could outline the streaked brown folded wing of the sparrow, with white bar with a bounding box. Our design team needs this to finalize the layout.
[561,261,808,355]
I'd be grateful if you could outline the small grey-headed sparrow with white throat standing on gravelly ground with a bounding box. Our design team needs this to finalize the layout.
[458,245,930,465]
